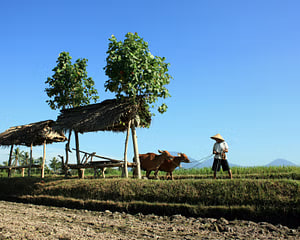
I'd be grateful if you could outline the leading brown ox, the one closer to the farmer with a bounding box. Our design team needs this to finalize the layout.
[154,153,190,180]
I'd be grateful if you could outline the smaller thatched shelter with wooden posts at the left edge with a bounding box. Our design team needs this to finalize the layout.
[0,120,67,178]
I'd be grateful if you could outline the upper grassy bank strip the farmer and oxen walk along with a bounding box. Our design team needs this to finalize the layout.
[0,178,300,207]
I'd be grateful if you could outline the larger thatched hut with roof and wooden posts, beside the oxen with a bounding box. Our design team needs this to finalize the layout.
[55,98,151,177]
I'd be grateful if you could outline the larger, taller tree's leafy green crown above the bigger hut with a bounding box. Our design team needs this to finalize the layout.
[104,33,172,124]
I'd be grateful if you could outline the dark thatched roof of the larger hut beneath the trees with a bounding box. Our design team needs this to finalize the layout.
[55,99,151,133]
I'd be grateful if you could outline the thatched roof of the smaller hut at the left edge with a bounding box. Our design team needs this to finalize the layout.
[0,120,67,147]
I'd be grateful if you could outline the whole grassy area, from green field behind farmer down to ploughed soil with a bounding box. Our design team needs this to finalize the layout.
[0,167,300,225]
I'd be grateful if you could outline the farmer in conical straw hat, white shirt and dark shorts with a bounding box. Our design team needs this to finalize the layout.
[211,133,232,179]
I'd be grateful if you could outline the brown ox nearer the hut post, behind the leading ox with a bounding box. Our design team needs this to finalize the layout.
[139,150,173,178]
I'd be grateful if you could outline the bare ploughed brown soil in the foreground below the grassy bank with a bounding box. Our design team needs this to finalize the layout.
[0,201,300,240]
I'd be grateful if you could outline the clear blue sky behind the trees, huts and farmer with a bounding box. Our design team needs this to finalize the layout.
[0,0,300,166]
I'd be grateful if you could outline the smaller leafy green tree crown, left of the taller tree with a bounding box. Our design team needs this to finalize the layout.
[45,52,99,109]
